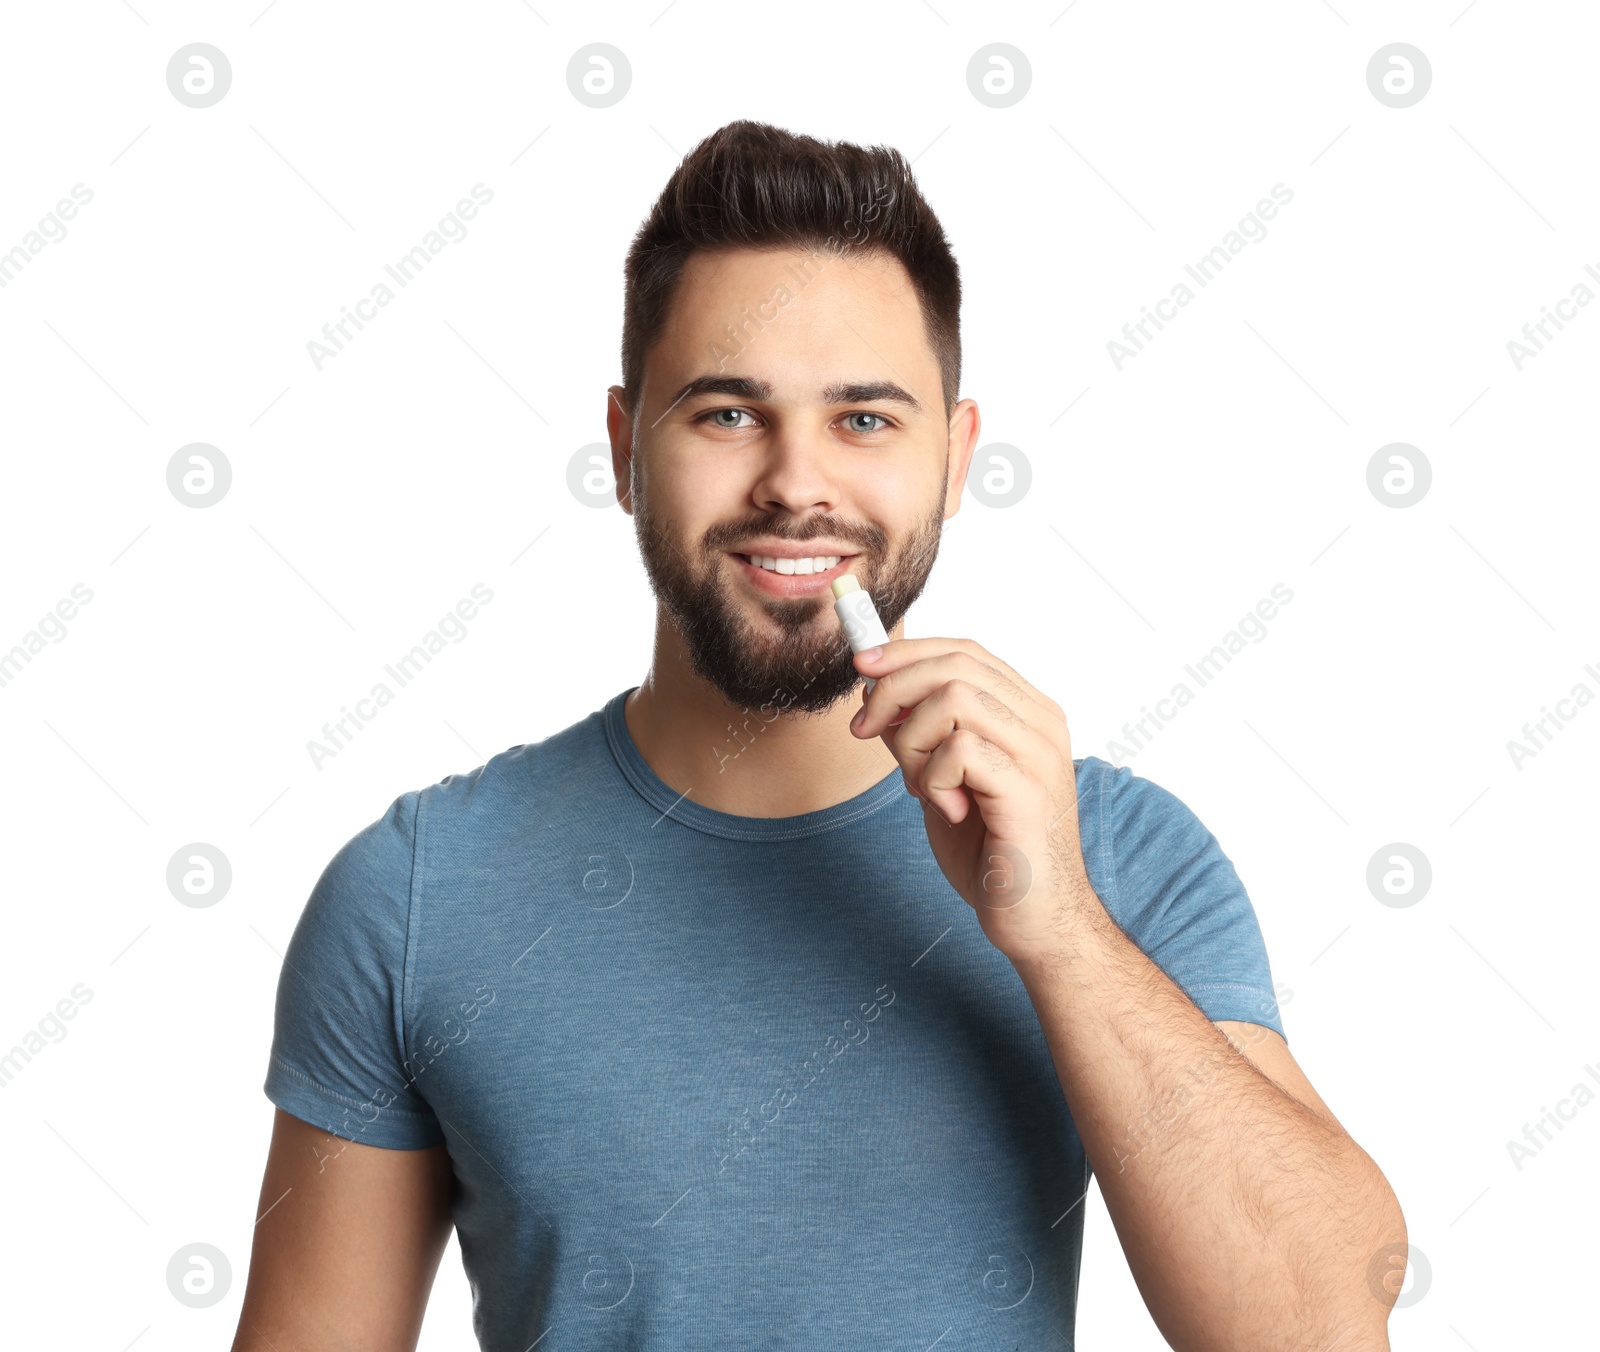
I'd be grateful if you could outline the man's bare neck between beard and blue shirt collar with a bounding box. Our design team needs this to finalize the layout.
[622,606,904,818]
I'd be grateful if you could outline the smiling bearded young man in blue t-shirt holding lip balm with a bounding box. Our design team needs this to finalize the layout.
[235,122,1405,1352]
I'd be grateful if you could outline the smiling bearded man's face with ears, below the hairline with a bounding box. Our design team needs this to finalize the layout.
[608,250,978,712]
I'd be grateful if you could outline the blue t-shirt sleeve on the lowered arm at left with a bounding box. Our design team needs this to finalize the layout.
[262,790,445,1150]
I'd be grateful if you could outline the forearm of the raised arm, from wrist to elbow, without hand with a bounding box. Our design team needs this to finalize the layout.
[1018,893,1405,1352]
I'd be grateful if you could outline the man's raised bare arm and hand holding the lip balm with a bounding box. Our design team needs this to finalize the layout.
[851,638,1405,1352]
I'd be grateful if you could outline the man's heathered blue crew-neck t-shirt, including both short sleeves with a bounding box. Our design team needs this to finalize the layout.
[266,691,1282,1352]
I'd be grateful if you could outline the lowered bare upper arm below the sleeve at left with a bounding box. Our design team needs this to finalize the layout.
[232,1109,453,1352]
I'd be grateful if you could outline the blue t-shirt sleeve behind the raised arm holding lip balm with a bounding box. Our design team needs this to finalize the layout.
[1099,762,1283,1037]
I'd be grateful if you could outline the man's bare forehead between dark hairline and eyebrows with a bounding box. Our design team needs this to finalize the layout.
[645,248,939,403]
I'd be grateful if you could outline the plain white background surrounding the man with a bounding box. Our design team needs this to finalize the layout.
[0,0,1600,1352]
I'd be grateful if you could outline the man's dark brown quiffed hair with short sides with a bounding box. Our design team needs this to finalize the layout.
[622,118,962,416]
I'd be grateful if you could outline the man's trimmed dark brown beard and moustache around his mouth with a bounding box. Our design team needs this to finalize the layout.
[634,470,949,715]
